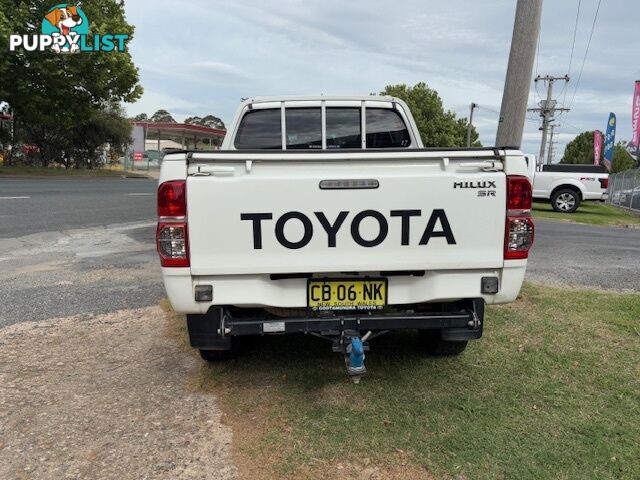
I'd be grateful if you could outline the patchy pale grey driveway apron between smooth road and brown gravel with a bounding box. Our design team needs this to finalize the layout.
[0,222,165,328]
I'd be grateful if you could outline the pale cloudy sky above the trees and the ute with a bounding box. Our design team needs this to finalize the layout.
[125,0,640,162]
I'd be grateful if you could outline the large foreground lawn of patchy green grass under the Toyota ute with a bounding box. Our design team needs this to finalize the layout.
[162,285,640,480]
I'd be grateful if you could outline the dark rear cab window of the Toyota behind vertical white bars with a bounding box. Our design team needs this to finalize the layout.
[234,106,411,150]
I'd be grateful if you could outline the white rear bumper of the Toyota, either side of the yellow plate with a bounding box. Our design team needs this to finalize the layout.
[163,260,527,314]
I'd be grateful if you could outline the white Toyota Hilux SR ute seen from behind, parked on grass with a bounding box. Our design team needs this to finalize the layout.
[157,96,534,379]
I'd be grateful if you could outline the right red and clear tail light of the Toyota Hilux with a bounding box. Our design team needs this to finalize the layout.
[504,175,534,260]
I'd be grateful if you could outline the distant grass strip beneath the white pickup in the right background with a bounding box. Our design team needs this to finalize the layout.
[533,202,640,225]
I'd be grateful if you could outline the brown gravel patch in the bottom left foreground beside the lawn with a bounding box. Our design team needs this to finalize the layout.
[0,307,236,480]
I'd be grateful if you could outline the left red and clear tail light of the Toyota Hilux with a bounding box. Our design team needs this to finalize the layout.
[156,180,190,267]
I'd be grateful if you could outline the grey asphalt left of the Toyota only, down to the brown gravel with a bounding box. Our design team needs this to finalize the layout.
[0,177,164,327]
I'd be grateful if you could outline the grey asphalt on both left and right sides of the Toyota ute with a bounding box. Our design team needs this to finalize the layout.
[0,177,640,327]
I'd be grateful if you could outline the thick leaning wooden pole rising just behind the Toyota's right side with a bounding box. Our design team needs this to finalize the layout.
[496,0,542,148]
